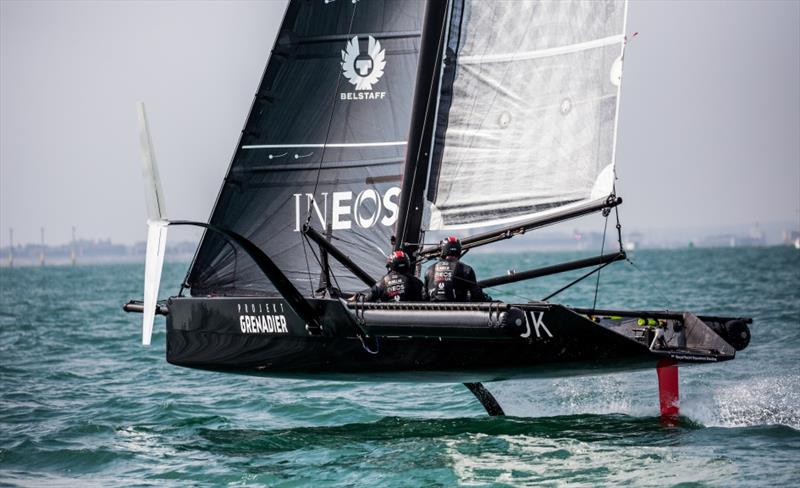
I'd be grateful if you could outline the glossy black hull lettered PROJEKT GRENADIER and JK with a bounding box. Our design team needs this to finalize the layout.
[159,298,748,382]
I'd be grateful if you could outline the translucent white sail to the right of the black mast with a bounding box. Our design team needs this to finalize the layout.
[426,0,626,230]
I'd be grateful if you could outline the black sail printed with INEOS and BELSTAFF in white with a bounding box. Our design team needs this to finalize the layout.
[187,0,423,296]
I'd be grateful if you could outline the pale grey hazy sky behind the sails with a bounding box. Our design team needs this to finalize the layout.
[0,0,800,245]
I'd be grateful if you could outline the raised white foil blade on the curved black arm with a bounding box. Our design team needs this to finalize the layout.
[137,102,168,346]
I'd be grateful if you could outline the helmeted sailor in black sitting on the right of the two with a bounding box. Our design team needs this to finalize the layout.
[425,236,491,302]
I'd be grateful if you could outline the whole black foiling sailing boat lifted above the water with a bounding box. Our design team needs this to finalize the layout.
[125,0,751,415]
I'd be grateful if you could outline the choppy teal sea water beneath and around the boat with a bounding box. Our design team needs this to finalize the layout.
[0,248,800,486]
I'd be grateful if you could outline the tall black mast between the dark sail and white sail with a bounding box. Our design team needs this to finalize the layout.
[394,0,449,256]
